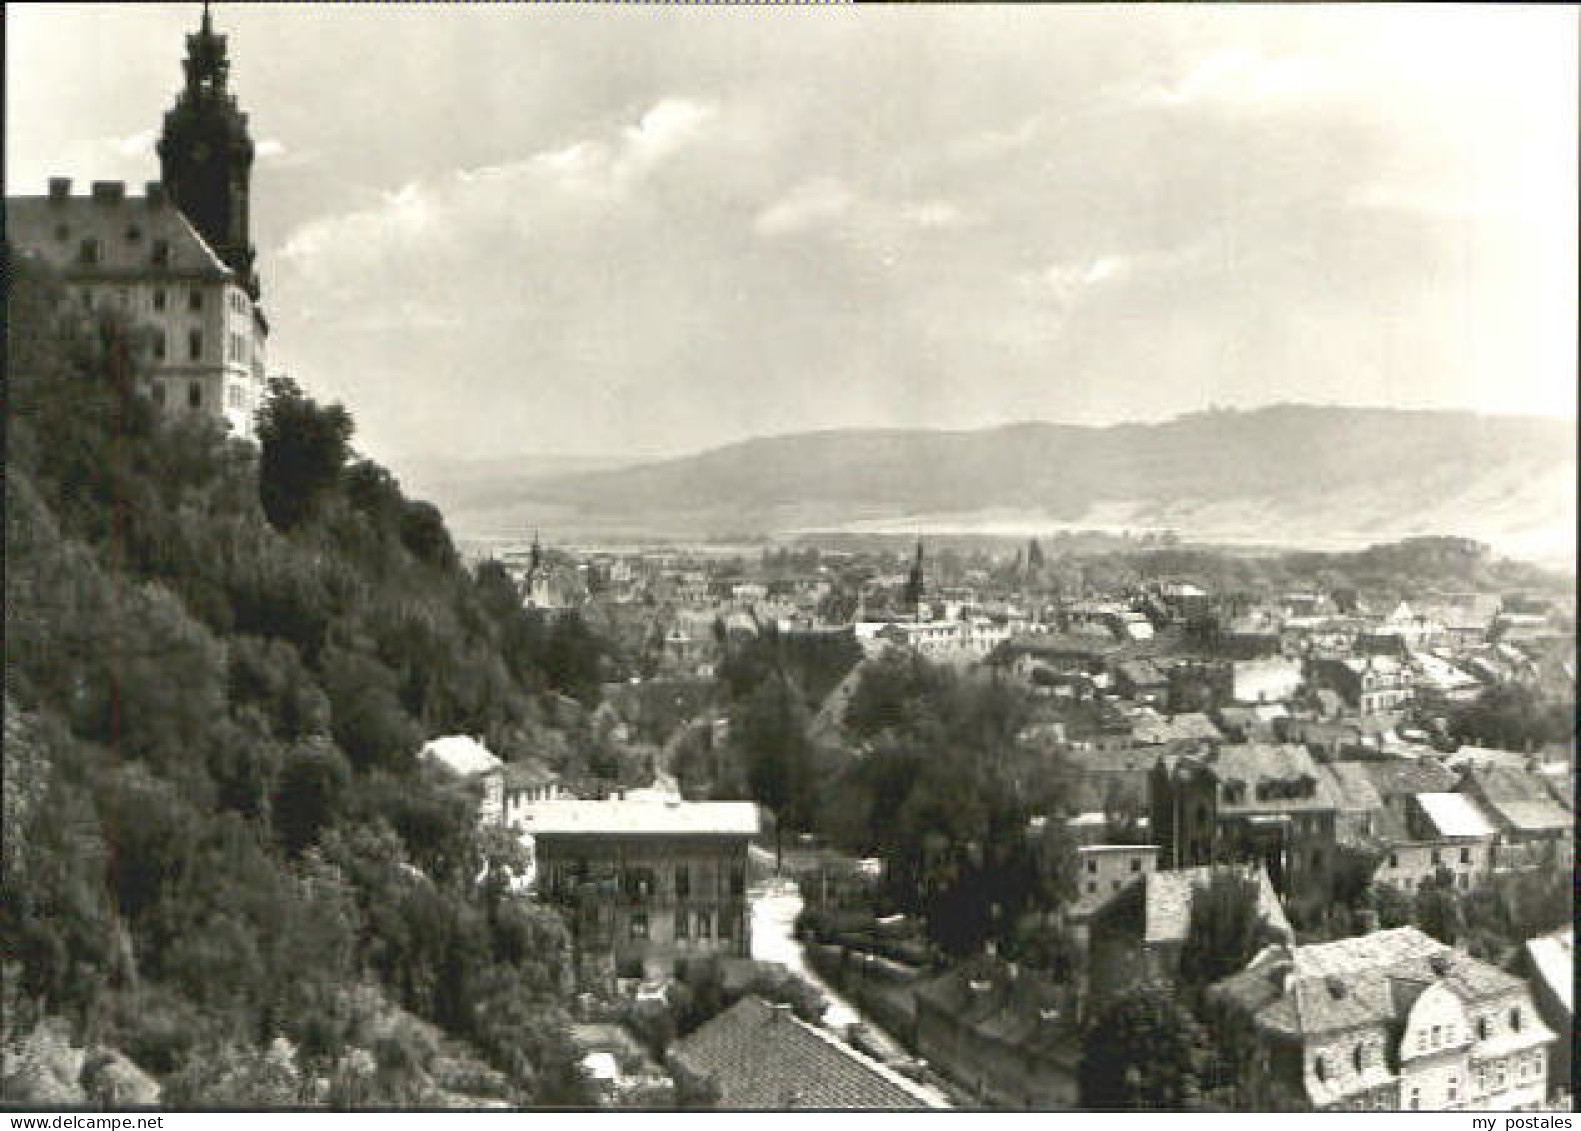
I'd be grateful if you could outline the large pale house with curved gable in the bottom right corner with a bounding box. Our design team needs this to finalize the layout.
[1208,927,1557,1110]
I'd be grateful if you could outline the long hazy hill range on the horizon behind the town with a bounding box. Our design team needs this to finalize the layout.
[414,405,1576,565]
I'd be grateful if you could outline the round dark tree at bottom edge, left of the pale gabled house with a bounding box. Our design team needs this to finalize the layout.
[1077,984,1216,1112]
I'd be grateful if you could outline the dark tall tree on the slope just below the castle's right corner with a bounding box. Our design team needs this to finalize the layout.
[258,376,354,530]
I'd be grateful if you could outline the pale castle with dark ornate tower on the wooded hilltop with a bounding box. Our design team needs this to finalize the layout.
[5,5,269,438]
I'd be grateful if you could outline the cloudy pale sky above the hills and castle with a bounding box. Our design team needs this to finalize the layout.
[5,3,1581,460]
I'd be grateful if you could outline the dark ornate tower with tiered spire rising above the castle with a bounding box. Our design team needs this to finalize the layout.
[158,3,258,302]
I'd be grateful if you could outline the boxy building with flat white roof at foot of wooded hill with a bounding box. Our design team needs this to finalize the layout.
[514,800,759,981]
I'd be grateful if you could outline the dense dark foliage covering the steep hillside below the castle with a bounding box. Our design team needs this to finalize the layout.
[0,261,583,1106]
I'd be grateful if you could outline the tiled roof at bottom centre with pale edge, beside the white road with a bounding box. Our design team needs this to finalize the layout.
[674,997,949,1110]
